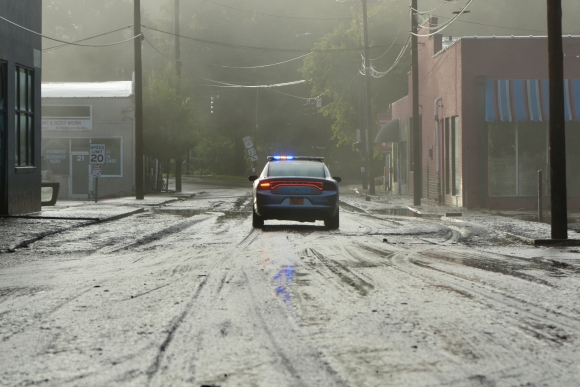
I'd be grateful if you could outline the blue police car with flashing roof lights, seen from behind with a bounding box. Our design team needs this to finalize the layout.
[248,156,341,229]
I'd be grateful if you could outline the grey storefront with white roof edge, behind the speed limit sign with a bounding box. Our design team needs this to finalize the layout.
[42,82,134,199]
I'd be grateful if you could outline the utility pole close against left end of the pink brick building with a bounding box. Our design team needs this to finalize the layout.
[411,0,423,206]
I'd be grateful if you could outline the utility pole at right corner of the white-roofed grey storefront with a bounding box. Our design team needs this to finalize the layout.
[133,0,145,200]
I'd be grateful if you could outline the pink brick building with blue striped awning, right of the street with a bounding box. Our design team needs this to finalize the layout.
[390,20,580,209]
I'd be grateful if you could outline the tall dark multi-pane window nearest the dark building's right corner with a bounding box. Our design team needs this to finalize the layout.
[14,66,34,167]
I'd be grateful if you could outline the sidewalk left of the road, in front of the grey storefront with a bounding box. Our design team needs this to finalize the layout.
[0,192,195,253]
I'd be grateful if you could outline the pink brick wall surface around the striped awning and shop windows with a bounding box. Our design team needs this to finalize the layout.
[393,29,580,208]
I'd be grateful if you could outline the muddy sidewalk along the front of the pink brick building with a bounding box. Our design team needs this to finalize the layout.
[341,185,580,245]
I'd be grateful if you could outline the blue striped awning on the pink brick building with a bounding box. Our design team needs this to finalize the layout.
[485,79,580,122]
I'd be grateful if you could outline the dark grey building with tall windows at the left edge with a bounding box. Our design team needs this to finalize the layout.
[0,0,42,214]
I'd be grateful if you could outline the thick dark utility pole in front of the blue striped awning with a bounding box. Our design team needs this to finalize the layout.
[547,0,568,239]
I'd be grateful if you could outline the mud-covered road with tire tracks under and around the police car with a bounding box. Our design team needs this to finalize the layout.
[0,186,580,387]
